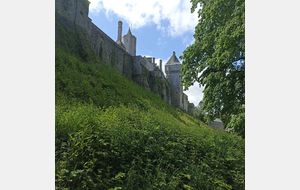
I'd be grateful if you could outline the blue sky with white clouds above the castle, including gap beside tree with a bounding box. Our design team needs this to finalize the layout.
[89,0,203,105]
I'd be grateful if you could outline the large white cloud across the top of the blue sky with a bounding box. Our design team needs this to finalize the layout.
[90,0,198,37]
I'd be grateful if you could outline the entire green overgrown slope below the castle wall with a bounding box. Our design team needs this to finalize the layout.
[55,16,245,190]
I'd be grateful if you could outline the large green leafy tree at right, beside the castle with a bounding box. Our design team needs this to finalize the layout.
[180,0,245,137]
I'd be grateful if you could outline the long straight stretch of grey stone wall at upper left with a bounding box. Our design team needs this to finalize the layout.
[55,0,133,80]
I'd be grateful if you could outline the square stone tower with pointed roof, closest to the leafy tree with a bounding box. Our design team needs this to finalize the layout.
[165,51,183,108]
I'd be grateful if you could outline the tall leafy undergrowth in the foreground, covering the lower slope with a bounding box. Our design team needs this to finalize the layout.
[56,103,244,189]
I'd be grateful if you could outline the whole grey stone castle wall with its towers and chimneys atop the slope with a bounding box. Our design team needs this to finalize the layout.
[55,0,194,115]
